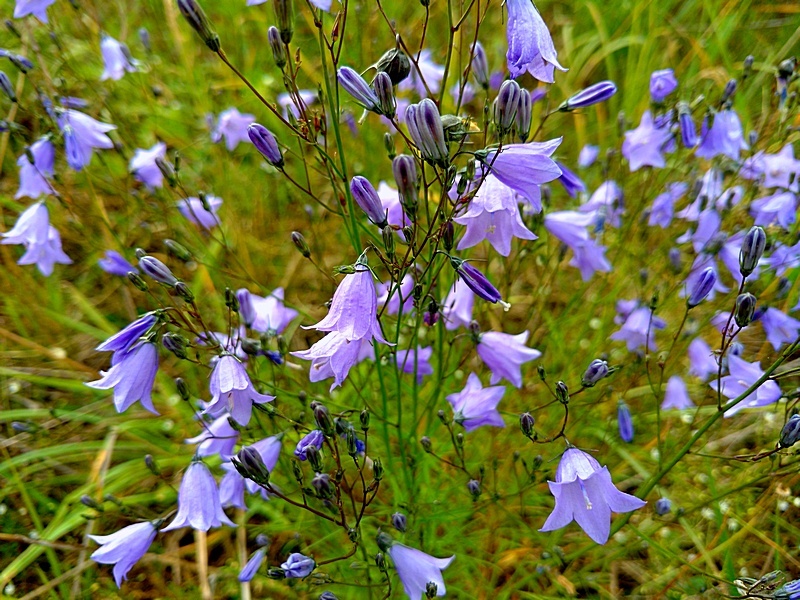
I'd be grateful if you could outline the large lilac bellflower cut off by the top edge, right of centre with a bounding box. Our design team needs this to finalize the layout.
[506,0,566,83]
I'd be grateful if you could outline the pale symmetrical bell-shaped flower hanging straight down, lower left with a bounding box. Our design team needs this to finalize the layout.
[161,460,236,531]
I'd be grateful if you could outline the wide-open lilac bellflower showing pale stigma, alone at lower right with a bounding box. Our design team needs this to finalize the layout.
[539,448,646,544]
